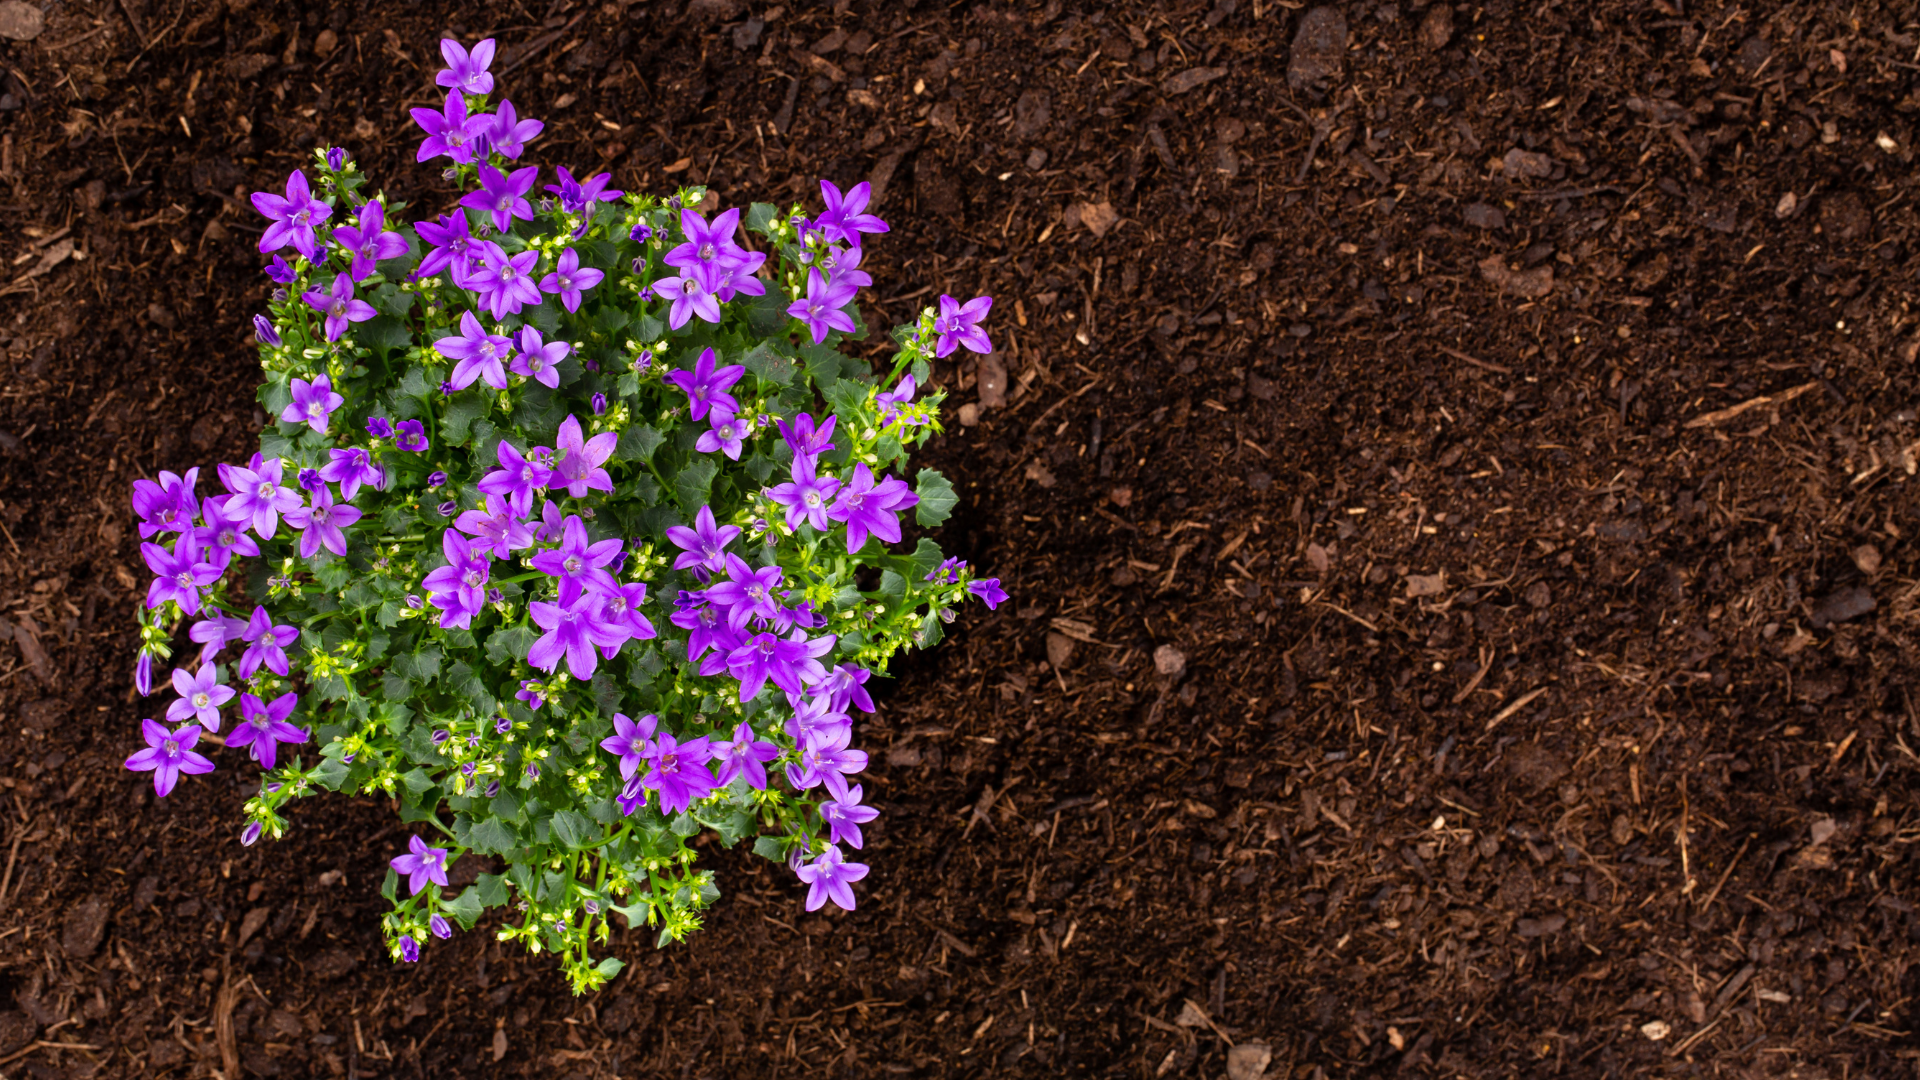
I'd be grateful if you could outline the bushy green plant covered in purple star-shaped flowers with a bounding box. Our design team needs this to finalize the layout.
[127,40,1006,994]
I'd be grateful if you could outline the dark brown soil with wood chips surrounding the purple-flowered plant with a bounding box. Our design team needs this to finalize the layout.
[0,0,1920,1078]
